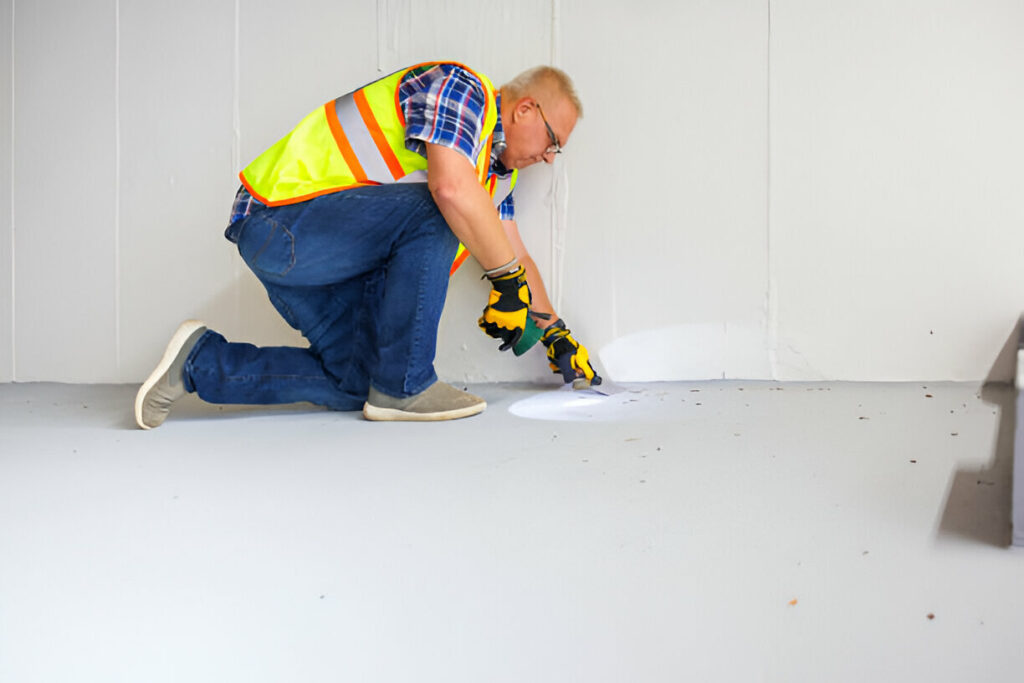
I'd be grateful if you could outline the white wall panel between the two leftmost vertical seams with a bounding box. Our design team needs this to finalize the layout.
[11,0,119,380]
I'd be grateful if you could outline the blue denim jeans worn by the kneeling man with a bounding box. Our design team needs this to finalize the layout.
[184,183,459,411]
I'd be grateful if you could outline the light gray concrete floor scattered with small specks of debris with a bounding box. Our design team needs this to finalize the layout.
[0,382,1024,683]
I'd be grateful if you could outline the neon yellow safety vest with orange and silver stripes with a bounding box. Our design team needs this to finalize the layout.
[239,62,518,273]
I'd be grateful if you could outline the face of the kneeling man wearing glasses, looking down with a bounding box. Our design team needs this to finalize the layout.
[501,96,577,169]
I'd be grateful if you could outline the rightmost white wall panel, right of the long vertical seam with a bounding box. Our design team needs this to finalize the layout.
[770,0,1024,380]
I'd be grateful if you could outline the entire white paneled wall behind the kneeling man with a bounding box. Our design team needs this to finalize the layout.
[0,0,1024,382]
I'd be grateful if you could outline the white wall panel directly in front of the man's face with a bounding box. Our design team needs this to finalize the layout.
[563,0,770,380]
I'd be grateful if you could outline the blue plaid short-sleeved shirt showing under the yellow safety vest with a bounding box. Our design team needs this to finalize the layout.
[230,63,515,223]
